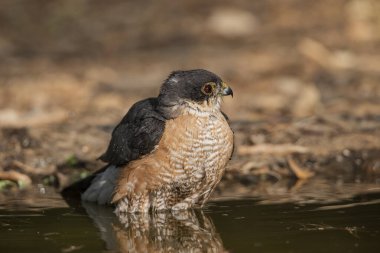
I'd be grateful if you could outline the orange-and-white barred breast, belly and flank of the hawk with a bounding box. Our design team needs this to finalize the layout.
[114,110,233,212]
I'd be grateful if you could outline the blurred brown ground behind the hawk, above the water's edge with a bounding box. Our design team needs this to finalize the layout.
[0,0,380,199]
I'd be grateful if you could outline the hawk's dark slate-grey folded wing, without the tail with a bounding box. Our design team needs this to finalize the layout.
[99,98,165,166]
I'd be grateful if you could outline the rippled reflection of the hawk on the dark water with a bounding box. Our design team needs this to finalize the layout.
[83,203,226,252]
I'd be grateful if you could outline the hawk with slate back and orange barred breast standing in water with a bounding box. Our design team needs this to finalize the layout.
[62,69,234,215]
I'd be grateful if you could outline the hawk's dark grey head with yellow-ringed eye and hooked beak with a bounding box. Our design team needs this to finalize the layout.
[158,69,233,116]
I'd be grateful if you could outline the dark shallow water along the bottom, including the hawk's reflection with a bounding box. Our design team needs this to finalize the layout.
[0,193,380,252]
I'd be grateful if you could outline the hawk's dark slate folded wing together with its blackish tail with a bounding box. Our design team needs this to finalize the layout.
[61,98,166,204]
